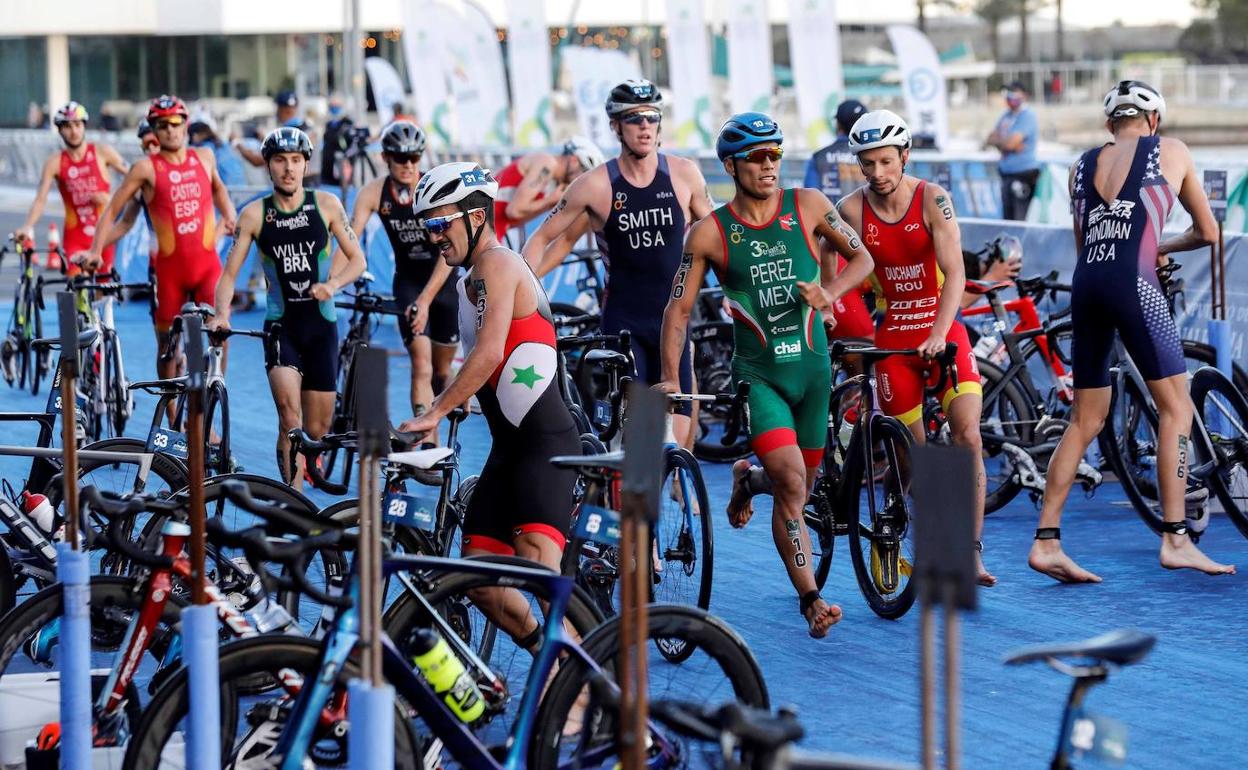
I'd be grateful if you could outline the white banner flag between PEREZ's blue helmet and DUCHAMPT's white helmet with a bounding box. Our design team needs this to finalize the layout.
[789,0,845,150]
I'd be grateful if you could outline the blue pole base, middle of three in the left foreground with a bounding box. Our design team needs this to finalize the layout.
[182,604,221,770]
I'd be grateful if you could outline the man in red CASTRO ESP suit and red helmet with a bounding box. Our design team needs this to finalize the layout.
[84,96,235,378]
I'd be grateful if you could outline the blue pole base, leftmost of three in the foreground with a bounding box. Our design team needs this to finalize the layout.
[56,543,91,770]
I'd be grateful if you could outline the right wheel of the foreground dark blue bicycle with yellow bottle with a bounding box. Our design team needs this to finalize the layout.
[529,604,769,770]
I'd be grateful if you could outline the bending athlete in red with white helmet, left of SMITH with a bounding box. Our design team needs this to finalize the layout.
[494,136,607,241]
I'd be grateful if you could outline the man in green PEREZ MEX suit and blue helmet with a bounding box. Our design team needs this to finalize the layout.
[658,112,871,638]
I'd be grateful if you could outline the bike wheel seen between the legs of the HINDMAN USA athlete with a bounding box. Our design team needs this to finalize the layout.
[1099,377,1163,534]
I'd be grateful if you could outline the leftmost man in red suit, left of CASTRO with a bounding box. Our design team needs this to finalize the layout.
[14,101,129,276]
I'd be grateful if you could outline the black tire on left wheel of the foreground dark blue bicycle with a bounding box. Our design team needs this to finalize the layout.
[122,636,422,770]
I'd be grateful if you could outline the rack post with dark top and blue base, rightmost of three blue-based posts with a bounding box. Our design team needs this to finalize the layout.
[347,347,394,770]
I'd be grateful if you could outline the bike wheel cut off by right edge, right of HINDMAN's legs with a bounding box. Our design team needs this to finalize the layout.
[1192,368,1248,537]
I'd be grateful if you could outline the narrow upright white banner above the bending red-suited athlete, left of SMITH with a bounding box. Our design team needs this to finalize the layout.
[507,0,553,147]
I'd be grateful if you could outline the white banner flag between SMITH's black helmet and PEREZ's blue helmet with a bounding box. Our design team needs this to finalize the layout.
[668,0,718,150]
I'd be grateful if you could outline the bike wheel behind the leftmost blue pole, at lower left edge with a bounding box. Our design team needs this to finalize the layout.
[0,575,183,740]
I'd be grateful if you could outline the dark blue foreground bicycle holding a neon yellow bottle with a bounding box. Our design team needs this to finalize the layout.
[125,476,766,770]
